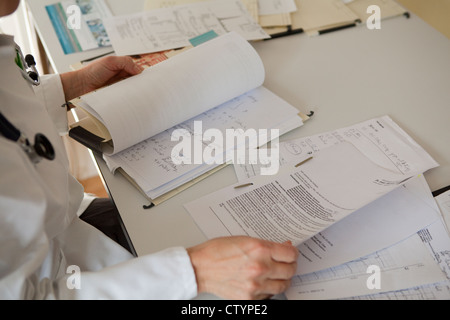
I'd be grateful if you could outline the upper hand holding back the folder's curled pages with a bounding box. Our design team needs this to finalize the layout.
[60,56,143,101]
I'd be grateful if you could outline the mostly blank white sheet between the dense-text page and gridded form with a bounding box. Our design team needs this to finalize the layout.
[297,175,440,275]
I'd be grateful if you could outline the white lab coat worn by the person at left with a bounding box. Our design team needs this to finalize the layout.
[0,35,197,299]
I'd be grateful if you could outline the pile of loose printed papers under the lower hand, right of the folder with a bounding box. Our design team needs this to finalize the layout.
[185,116,450,299]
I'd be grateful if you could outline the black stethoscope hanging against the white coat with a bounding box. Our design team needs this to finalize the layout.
[0,45,55,164]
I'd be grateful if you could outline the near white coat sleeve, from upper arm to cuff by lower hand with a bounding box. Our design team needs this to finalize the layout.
[0,141,197,299]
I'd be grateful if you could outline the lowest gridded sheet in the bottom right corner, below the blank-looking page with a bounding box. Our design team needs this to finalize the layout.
[285,221,450,300]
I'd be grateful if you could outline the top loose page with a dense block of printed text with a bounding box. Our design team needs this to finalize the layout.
[185,142,429,245]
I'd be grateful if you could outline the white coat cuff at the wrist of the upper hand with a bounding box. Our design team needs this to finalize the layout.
[33,74,68,135]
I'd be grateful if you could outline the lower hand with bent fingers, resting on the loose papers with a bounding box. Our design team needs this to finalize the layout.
[187,236,299,300]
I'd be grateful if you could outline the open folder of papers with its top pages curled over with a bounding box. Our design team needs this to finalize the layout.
[69,33,303,204]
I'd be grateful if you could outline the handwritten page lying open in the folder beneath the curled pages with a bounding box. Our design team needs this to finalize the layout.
[104,87,303,199]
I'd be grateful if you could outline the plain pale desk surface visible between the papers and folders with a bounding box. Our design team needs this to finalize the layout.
[29,0,450,255]
